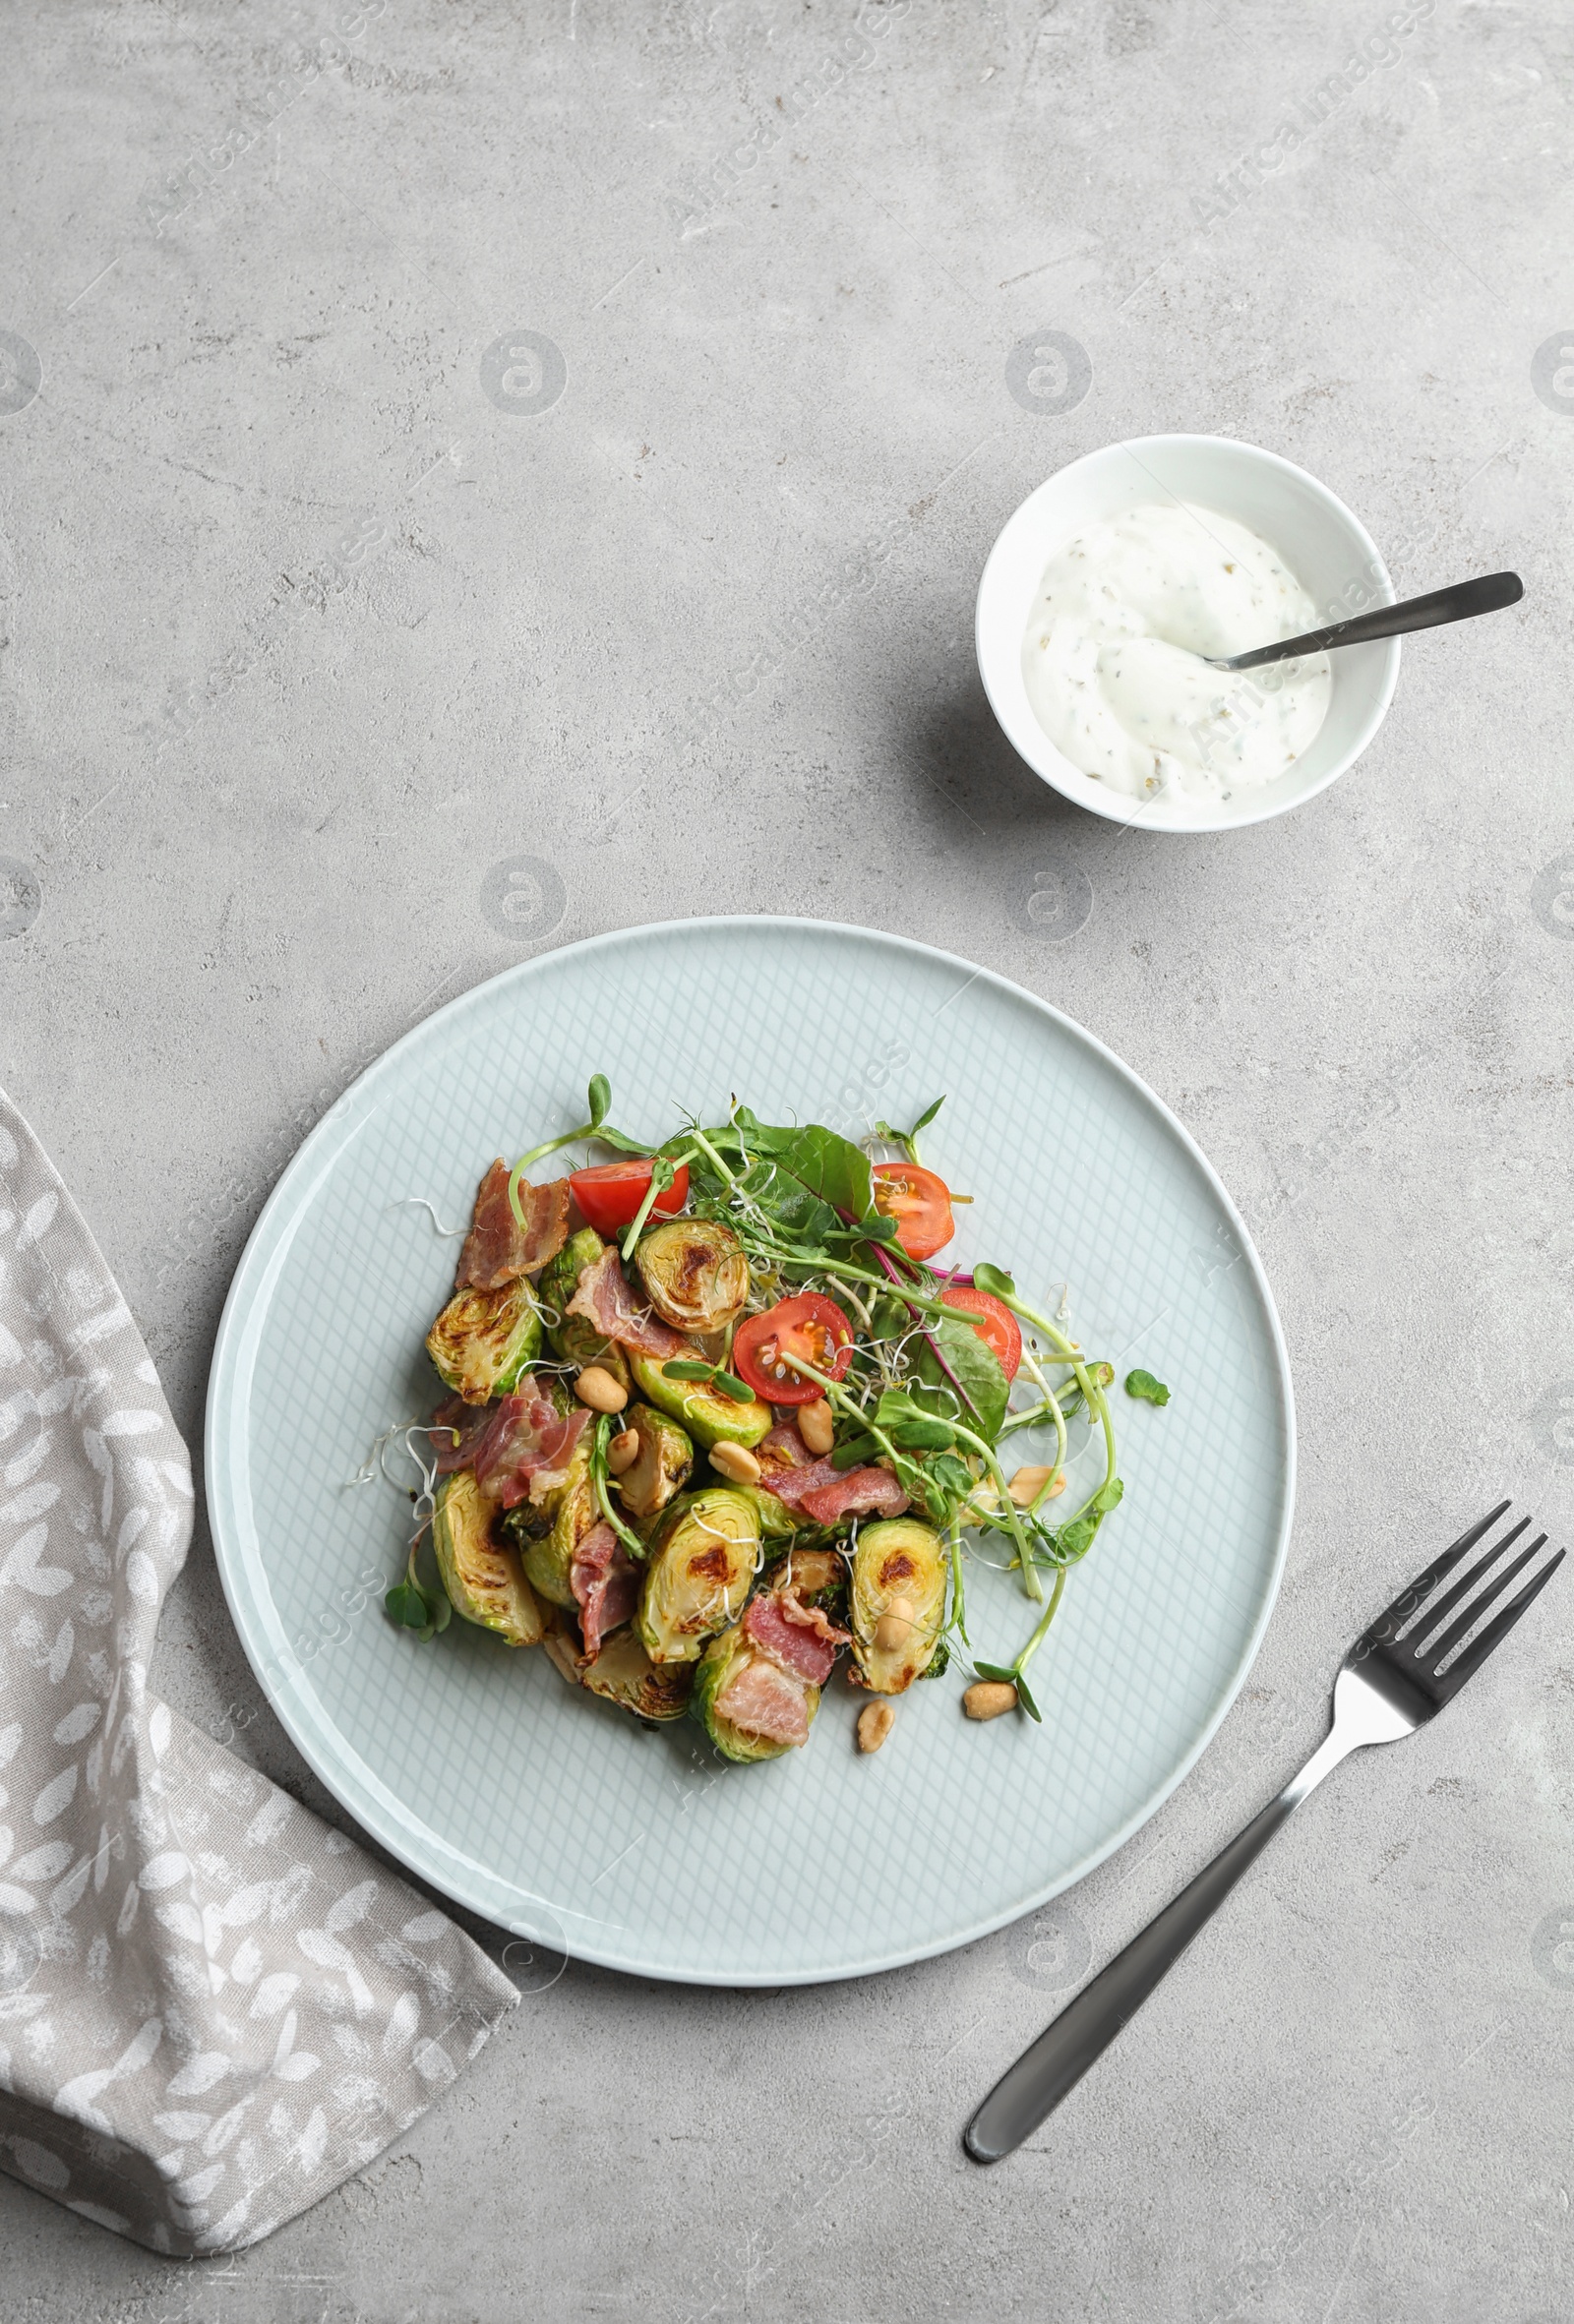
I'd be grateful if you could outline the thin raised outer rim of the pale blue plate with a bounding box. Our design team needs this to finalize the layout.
[203,914,1298,1990]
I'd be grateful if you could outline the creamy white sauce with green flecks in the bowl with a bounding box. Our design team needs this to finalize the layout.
[1023,502,1330,806]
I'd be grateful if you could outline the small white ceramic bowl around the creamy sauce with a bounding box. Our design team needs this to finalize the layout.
[977,435,1400,832]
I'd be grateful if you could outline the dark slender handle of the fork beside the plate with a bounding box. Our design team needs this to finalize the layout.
[962,1734,1356,2164]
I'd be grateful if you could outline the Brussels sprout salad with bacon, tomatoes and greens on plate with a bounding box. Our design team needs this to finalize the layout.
[360,1074,1170,1764]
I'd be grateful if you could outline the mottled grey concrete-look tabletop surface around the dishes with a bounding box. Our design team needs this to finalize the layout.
[0,0,1574,2324]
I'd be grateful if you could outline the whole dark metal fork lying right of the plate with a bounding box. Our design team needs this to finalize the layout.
[965,1501,1565,2164]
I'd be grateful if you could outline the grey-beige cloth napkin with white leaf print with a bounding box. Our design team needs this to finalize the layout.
[0,1090,518,2256]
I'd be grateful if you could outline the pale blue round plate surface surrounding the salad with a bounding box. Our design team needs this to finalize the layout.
[207,921,1295,1985]
